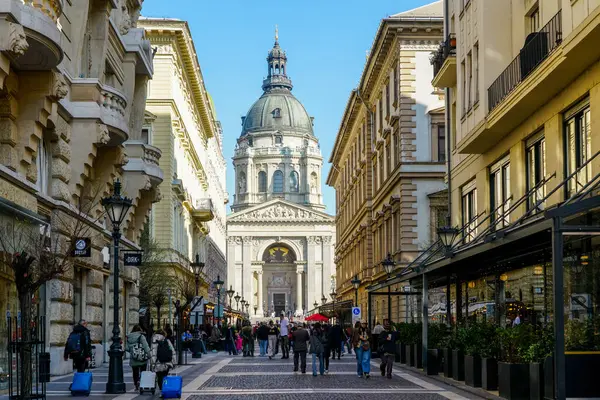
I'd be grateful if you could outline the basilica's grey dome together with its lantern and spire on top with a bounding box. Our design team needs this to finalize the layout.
[242,35,313,136]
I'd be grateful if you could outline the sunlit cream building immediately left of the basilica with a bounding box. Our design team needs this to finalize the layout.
[140,18,228,303]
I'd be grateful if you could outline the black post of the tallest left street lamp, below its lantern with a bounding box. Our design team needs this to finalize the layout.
[106,226,125,394]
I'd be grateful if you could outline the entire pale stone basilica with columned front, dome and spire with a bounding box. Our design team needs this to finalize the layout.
[227,32,335,318]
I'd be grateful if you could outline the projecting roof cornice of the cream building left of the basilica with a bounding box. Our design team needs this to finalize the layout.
[138,18,216,137]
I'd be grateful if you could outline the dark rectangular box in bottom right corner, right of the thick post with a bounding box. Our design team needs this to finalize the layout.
[565,353,600,398]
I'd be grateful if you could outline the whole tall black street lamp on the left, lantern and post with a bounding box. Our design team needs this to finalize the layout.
[101,179,131,394]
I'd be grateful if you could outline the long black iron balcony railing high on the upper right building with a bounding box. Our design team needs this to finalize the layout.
[488,11,562,112]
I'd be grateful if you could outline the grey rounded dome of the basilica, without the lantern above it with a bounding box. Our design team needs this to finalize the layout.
[242,90,313,135]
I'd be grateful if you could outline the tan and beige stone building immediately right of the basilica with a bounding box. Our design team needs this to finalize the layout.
[327,1,447,321]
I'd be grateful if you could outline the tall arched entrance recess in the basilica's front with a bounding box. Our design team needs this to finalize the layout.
[262,243,297,316]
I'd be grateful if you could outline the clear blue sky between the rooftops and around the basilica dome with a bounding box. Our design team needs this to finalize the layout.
[142,0,433,214]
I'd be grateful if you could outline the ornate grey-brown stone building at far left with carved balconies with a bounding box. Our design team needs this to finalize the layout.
[0,0,158,376]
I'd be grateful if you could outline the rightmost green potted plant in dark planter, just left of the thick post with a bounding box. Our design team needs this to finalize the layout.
[523,326,554,400]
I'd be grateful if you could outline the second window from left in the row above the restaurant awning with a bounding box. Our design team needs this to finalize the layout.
[490,156,510,229]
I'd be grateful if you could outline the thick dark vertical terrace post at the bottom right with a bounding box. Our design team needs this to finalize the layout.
[552,217,567,400]
